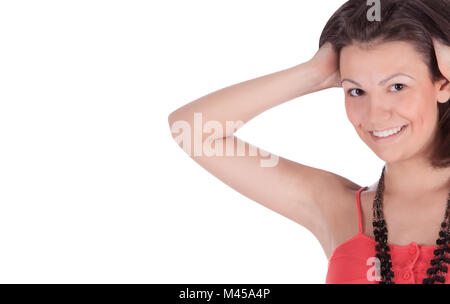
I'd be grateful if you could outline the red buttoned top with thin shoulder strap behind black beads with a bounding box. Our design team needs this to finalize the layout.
[326,187,450,284]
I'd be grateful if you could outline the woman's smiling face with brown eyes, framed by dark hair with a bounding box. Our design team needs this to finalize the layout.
[340,41,450,162]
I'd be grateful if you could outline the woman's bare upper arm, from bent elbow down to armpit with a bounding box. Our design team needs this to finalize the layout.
[169,129,359,260]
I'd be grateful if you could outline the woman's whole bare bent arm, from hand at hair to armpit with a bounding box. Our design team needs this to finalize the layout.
[169,44,359,256]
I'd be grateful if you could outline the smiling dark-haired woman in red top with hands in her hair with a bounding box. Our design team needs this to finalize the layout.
[169,0,450,284]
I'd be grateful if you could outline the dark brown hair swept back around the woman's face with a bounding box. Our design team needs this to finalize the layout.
[319,0,450,168]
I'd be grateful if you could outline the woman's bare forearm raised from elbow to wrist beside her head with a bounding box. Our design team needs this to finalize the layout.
[169,61,323,141]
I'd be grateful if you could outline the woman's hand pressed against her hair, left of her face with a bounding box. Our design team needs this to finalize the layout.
[309,42,342,90]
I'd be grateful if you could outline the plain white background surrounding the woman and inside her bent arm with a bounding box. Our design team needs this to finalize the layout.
[0,0,383,283]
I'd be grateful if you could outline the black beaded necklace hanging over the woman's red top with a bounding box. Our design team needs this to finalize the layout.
[372,165,450,284]
